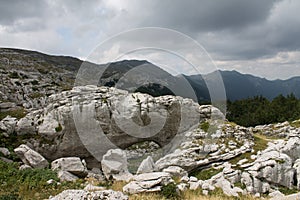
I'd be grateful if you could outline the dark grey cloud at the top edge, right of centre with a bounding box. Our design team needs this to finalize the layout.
[135,0,276,31]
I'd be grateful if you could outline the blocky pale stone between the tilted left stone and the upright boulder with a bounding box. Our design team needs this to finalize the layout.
[51,157,87,177]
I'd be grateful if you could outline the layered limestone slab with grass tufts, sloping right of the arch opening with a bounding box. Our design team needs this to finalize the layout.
[155,121,254,172]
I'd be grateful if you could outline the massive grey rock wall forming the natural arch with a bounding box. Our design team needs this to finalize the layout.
[5,86,203,168]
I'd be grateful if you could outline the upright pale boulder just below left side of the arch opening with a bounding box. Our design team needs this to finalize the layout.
[101,149,132,181]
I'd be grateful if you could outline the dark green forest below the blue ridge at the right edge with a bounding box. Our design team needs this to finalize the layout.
[226,94,300,126]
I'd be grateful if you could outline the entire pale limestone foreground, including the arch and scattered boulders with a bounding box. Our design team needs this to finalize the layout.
[0,86,300,199]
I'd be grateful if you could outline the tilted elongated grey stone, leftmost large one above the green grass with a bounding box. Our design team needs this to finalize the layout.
[14,144,49,168]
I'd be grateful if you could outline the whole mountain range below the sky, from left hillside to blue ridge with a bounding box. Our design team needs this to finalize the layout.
[0,48,300,103]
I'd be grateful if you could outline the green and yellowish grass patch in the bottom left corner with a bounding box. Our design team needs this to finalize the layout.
[0,161,83,200]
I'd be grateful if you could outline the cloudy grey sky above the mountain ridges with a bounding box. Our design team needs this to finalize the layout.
[0,0,300,79]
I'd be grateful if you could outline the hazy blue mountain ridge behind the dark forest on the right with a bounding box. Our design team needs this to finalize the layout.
[185,71,300,100]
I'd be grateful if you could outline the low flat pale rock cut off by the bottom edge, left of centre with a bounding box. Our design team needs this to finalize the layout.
[49,190,128,200]
